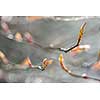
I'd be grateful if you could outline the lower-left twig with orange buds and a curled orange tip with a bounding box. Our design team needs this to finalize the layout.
[0,51,53,71]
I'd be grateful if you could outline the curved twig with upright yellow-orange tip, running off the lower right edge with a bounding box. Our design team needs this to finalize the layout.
[59,54,100,81]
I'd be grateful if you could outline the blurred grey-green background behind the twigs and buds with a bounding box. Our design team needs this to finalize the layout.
[0,16,100,83]
